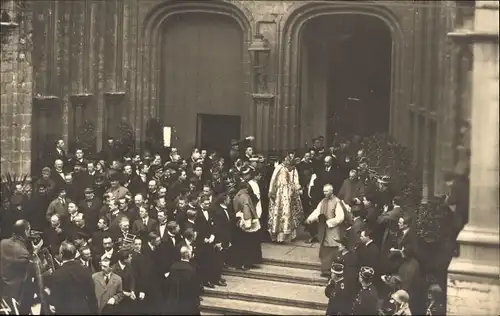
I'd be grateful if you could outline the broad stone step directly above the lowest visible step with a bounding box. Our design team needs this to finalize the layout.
[204,276,328,312]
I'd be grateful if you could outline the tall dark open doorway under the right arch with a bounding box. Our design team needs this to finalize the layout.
[298,14,392,141]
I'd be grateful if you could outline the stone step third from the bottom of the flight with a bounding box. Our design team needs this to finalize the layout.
[224,264,328,286]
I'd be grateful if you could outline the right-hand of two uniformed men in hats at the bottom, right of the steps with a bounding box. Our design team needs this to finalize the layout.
[352,266,379,315]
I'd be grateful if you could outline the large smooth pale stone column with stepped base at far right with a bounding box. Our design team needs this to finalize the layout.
[447,1,500,315]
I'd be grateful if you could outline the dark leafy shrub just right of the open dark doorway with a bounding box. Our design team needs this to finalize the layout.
[363,134,422,209]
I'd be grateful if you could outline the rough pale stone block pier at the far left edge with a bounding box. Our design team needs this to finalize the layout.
[0,1,33,174]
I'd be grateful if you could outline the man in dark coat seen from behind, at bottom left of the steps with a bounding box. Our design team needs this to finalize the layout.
[167,247,200,315]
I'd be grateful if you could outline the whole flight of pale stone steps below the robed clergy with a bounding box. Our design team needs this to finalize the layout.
[201,244,328,315]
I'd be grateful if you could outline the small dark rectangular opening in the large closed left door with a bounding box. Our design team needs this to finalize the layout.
[196,114,241,155]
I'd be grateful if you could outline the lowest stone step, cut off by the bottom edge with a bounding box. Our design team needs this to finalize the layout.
[201,297,325,316]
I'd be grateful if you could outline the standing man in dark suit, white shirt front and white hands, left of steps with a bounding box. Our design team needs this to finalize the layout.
[195,197,219,288]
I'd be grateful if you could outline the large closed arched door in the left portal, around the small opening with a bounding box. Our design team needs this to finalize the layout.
[160,13,247,156]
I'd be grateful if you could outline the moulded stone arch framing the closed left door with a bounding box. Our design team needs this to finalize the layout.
[135,0,254,144]
